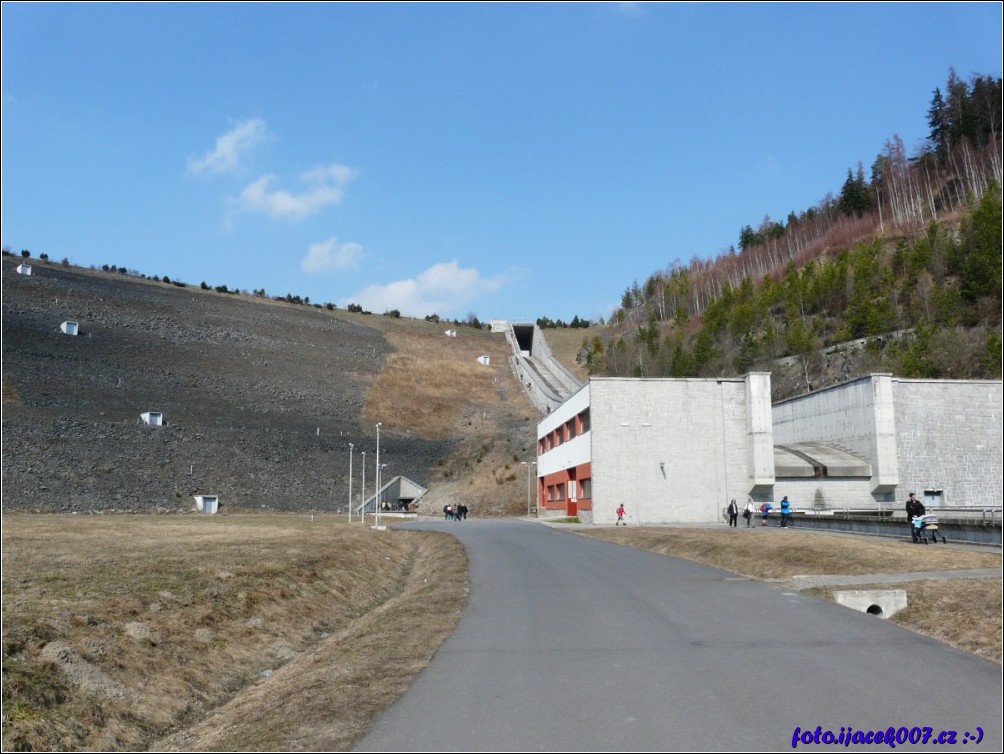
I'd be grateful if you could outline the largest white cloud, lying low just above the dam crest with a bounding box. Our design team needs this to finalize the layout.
[342,259,510,316]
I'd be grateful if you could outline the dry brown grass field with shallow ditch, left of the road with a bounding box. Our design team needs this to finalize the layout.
[3,514,466,751]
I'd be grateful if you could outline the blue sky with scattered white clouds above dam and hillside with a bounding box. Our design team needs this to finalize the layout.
[0,2,1002,320]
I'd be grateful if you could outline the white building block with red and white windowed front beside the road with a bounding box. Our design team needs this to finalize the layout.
[537,372,774,524]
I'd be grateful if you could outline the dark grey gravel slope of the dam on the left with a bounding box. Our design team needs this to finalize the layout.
[3,256,452,512]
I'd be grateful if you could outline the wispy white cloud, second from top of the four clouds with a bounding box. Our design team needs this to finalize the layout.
[230,164,356,220]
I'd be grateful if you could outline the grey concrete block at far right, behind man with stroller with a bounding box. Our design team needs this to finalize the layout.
[773,374,1004,508]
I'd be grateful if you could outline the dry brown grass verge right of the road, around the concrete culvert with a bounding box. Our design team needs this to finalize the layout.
[577,527,1002,664]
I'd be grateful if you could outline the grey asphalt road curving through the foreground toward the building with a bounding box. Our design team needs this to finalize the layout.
[355,520,1002,752]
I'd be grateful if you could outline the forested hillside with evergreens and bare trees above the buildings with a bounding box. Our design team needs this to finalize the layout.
[582,71,1002,399]
